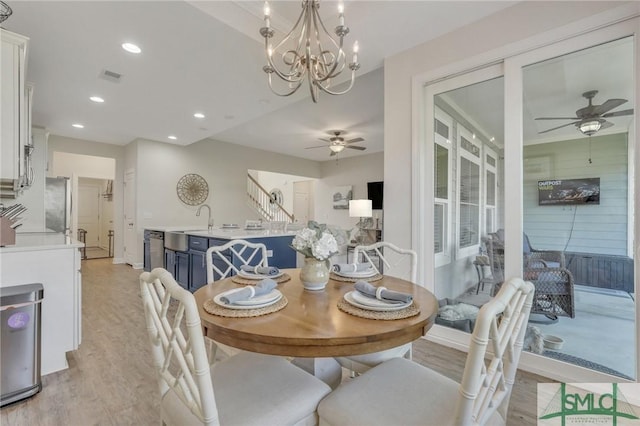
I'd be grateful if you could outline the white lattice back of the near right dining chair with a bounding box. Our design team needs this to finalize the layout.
[455,278,535,425]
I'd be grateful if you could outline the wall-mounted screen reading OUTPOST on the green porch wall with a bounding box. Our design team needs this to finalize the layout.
[538,178,600,206]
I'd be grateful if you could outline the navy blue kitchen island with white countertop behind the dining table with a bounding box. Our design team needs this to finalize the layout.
[144,226,297,292]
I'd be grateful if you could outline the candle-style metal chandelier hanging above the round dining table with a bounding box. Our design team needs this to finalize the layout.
[260,0,360,102]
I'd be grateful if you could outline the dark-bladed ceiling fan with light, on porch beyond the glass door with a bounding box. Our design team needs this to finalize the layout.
[536,90,633,136]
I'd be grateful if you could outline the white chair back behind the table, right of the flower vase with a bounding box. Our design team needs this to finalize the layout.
[353,241,418,283]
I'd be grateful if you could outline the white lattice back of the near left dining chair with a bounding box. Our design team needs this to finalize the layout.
[140,268,219,425]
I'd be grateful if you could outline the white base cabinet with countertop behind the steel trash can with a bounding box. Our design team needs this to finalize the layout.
[0,232,84,375]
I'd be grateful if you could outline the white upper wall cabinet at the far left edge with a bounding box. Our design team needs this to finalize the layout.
[0,29,32,197]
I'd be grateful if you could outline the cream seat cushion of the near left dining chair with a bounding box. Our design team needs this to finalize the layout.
[163,352,331,426]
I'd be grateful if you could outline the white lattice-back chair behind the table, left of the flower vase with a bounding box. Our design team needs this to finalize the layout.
[205,240,269,358]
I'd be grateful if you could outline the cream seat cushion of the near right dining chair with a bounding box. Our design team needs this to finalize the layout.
[318,358,504,426]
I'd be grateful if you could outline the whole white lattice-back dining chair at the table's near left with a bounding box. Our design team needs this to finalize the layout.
[140,268,331,426]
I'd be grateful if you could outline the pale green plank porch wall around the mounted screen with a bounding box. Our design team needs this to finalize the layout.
[523,133,629,256]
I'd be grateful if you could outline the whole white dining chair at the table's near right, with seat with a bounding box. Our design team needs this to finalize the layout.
[318,278,534,426]
